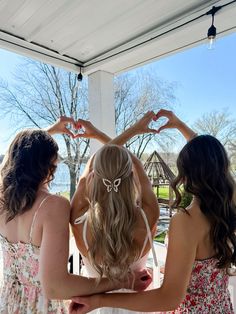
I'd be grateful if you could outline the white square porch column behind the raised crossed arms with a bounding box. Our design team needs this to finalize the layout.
[88,71,116,154]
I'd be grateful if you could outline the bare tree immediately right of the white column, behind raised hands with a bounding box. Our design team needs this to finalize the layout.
[115,70,176,158]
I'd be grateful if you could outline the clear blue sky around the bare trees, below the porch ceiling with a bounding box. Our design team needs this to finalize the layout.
[0,33,236,154]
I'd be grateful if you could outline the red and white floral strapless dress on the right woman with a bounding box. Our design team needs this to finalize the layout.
[167,258,234,314]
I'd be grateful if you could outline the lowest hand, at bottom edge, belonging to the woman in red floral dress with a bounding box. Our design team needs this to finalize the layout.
[69,295,100,314]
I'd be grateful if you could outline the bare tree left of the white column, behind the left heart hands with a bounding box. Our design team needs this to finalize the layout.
[0,60,89,197]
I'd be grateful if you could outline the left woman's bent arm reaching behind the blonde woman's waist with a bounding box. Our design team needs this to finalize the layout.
[39,196,146,299]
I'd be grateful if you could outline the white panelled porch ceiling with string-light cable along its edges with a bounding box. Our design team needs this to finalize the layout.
[0,0,236,74]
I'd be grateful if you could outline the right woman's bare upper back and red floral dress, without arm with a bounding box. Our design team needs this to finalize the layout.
[168,199,233,314]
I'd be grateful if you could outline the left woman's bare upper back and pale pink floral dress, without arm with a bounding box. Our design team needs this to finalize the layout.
[0,191,66,313]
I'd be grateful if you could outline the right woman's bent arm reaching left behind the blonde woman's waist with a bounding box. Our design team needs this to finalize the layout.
[70,213,197,314]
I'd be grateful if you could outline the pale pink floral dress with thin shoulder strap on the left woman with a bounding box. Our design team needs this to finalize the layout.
[0,198,68,314]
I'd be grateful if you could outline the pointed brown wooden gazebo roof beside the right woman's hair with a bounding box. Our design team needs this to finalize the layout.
[144,151,175,184]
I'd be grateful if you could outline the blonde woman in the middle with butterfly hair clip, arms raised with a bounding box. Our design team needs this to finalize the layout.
[71,112,159,313]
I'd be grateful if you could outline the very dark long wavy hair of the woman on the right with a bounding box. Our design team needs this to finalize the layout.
[172,135,236,268]
